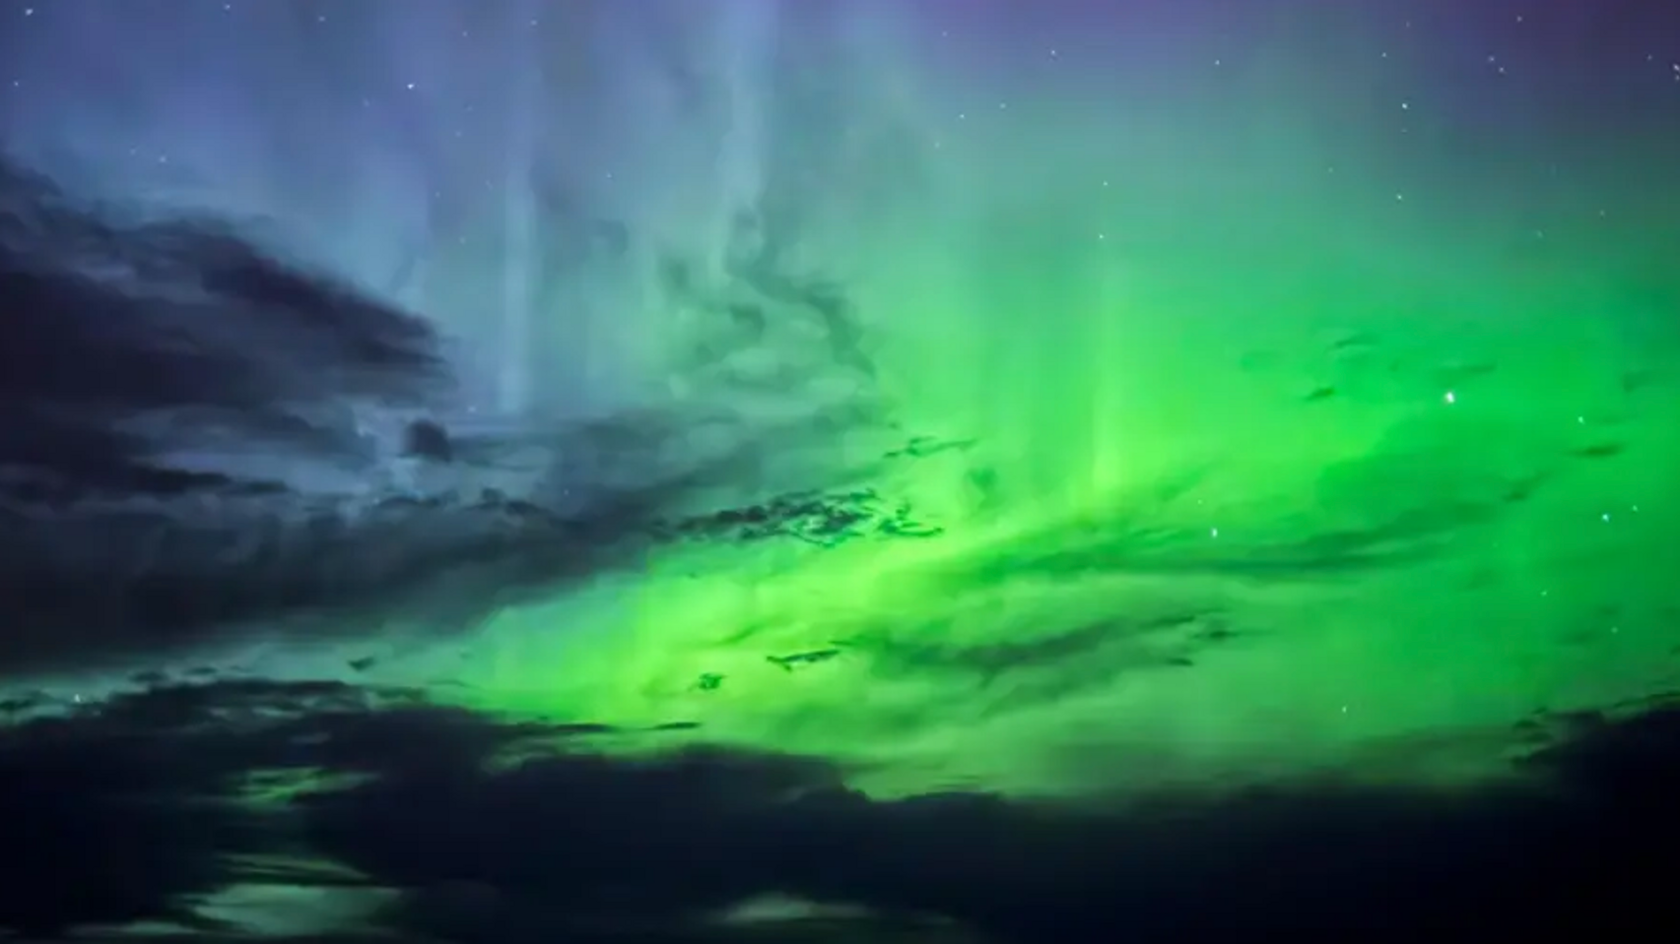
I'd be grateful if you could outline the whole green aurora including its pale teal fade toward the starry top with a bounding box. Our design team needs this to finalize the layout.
[16,1,1680,809]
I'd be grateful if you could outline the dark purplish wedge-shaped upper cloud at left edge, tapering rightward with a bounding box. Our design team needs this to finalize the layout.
[0,153,447,483]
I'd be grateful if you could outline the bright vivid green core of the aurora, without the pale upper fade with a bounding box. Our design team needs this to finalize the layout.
[430,170,1680,791]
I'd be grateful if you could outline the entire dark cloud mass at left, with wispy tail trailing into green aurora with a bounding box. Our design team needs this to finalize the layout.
[0,154,926,672]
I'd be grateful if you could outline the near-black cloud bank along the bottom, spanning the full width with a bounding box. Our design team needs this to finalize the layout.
[0,680,1680,942]
